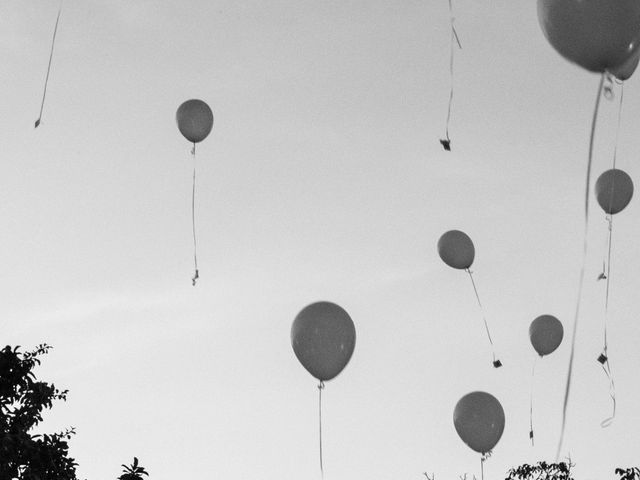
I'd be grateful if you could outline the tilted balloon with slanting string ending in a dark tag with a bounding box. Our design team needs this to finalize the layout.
[438,230,502,368]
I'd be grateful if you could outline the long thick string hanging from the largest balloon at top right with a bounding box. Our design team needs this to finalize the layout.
[556,73,605,462]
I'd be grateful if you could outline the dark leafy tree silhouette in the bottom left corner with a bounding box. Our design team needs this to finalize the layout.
[0,344,77,480]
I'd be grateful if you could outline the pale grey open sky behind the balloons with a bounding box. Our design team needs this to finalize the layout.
[0,0,640,480]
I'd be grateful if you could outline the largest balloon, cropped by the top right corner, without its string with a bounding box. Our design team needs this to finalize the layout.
[538,0,640,73]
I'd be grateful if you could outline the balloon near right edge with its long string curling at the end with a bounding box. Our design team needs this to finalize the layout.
[595,167,633,427]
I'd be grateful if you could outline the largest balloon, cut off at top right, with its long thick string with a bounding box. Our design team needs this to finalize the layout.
[537,0,640,461]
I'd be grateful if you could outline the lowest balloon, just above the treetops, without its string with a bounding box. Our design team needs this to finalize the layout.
[453,392,504,454]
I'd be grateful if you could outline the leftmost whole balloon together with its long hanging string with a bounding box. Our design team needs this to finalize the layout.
[176,99,213,286]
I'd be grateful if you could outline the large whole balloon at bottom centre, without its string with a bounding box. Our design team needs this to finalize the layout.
[291,302,356,381]
